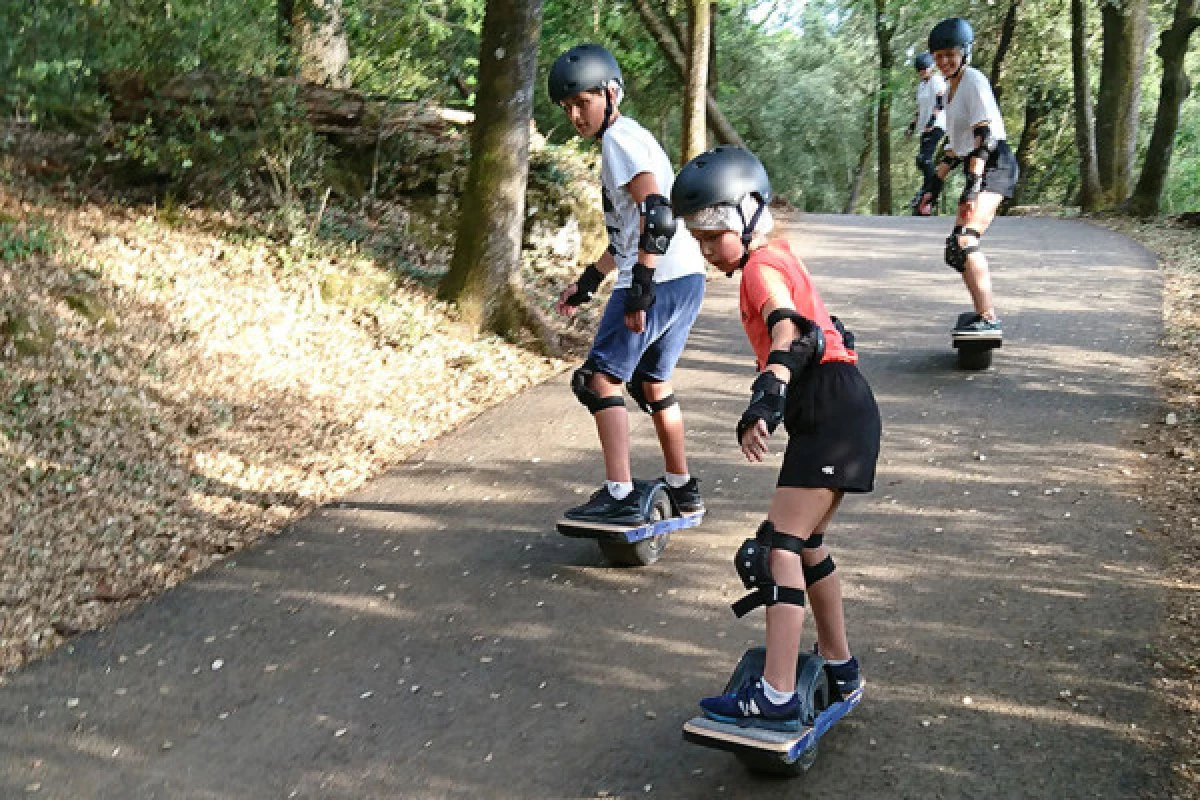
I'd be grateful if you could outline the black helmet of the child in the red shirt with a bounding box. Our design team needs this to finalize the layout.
[671,145,772,217]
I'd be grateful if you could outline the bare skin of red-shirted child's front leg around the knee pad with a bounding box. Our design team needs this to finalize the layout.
[763,487,846,692]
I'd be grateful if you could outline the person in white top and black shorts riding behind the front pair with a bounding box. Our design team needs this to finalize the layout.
[929,17,1019,339]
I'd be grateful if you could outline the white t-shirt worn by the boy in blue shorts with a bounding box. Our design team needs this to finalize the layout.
[600,116,706,289]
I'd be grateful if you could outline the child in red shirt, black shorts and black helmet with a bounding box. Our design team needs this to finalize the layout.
[671,146,882,732]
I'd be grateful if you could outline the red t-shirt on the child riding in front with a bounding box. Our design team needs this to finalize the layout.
[738,239,858,369]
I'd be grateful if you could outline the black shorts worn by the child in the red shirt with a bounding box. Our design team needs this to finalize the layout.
[776,361,883,492]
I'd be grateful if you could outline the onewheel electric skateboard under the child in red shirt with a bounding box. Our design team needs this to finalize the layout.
[683,648,863,776]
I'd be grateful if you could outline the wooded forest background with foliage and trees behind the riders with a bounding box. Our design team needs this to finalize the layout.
[0,0,1200,220]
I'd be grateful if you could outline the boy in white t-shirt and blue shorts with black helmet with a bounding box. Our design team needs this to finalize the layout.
[547,44,706,525]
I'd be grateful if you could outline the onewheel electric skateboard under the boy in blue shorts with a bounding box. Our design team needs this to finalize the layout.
[556,480,704,566]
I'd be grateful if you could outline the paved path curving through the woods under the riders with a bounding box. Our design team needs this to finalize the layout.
[0,216,1165,800]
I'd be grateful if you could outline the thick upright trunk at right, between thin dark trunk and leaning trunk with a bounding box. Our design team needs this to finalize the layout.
[1096,0,1146,203]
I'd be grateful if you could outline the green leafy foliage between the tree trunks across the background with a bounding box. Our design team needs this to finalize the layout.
[0,0,1200,211]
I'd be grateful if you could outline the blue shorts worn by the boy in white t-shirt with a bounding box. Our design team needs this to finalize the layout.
[588,273,704,383]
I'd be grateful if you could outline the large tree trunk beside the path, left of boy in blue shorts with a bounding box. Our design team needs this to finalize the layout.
[438,0,553,345]
